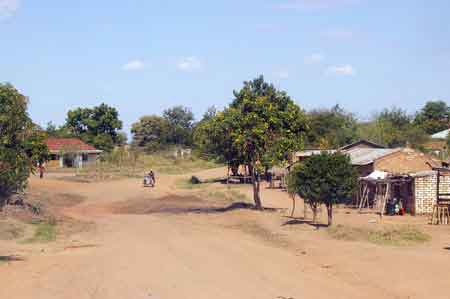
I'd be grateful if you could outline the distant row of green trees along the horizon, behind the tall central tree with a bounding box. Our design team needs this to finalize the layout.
[39,85,450,156]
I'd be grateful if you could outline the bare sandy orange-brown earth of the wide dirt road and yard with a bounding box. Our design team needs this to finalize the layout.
[0,169,450,299]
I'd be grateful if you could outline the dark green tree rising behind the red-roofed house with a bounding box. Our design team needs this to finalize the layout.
[65,103,123,151]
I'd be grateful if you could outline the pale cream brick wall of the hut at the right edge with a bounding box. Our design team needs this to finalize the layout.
[414,174,450,215]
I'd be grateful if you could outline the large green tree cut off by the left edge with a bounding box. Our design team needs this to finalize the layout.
[0,84,48,205]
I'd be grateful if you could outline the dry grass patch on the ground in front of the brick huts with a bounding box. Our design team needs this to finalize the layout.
[327,225,431,246]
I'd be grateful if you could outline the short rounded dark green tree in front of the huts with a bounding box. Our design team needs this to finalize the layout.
[288,153,357,225]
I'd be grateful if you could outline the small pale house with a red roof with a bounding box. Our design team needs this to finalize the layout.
[45,138,102,168]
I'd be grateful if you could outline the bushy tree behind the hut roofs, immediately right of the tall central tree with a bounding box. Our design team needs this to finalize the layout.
[307,105,358,149]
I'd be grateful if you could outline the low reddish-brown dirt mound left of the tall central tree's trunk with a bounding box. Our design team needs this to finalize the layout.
[111,195,253,215]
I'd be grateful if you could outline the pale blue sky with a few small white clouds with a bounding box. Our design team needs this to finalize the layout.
[0,0,450,134]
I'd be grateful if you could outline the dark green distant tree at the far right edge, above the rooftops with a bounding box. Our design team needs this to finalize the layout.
[414,101,450,134]
